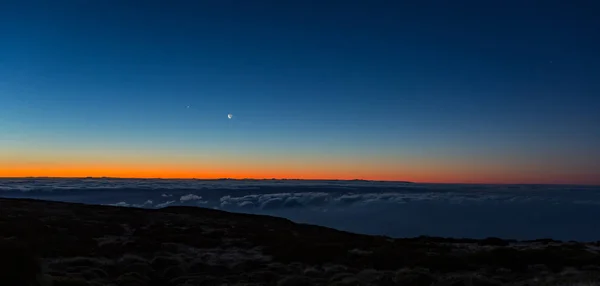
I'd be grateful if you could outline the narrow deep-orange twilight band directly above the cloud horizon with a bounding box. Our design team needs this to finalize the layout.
[0,163,600,185]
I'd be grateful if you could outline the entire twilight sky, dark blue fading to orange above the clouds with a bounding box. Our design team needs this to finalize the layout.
[0,0,600,184]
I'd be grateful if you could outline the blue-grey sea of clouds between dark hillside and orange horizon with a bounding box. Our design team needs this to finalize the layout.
[0,179,600,241]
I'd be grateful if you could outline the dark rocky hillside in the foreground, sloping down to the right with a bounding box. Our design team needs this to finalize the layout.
[0,199,600,286]
